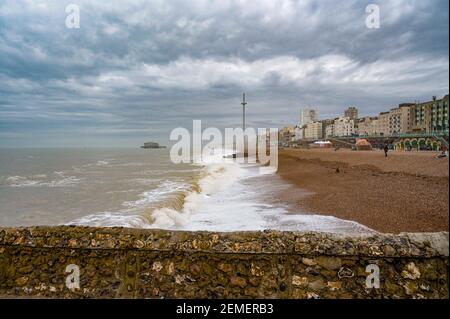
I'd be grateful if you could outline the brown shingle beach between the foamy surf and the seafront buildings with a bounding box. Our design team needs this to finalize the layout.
[277,149,449,233]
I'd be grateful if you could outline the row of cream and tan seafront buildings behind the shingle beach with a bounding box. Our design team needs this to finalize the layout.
[286,94,449,144]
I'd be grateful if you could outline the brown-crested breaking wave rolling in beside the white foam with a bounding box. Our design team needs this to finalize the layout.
[72,150,246,229]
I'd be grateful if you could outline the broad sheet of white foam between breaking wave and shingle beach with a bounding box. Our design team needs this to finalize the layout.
[183,168,372,233]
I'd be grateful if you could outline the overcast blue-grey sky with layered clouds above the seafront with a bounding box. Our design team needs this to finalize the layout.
[0,0,449,147]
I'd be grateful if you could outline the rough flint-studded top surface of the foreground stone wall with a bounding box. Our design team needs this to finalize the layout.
[0,226,449,258]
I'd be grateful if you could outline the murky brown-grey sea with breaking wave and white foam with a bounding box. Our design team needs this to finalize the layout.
[0,148,373,233]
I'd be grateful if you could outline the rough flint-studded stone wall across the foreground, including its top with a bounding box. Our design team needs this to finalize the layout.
[0,226,449,298]
